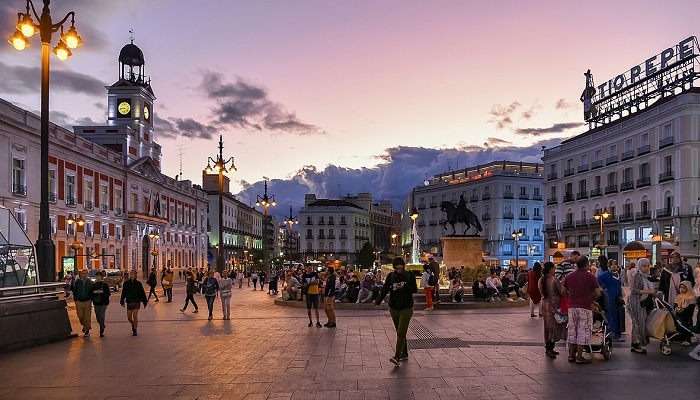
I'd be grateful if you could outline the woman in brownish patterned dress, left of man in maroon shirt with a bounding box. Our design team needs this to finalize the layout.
[540,261,566,359]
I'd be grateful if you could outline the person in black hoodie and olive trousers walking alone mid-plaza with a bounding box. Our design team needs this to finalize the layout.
[374,257,418,367]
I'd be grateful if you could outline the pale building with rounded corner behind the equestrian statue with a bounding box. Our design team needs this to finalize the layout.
[401,161,544,267]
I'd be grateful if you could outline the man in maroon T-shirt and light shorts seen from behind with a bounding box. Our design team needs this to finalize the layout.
[563,256,601,364]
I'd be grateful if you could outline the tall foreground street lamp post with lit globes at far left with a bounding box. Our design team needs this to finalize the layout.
[8,0,83,282]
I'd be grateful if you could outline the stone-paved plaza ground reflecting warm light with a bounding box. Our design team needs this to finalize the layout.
[0,282,700,400]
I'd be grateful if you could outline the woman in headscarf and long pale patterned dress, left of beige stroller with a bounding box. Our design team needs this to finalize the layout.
[627,258,656,354]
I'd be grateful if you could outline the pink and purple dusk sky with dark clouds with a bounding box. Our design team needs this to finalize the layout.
[0,0,700,218]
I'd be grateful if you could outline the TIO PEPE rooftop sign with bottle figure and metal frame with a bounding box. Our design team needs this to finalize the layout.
[581,36,700,128]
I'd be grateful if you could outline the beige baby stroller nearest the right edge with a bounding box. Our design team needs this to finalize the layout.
[646,297,695,355]
